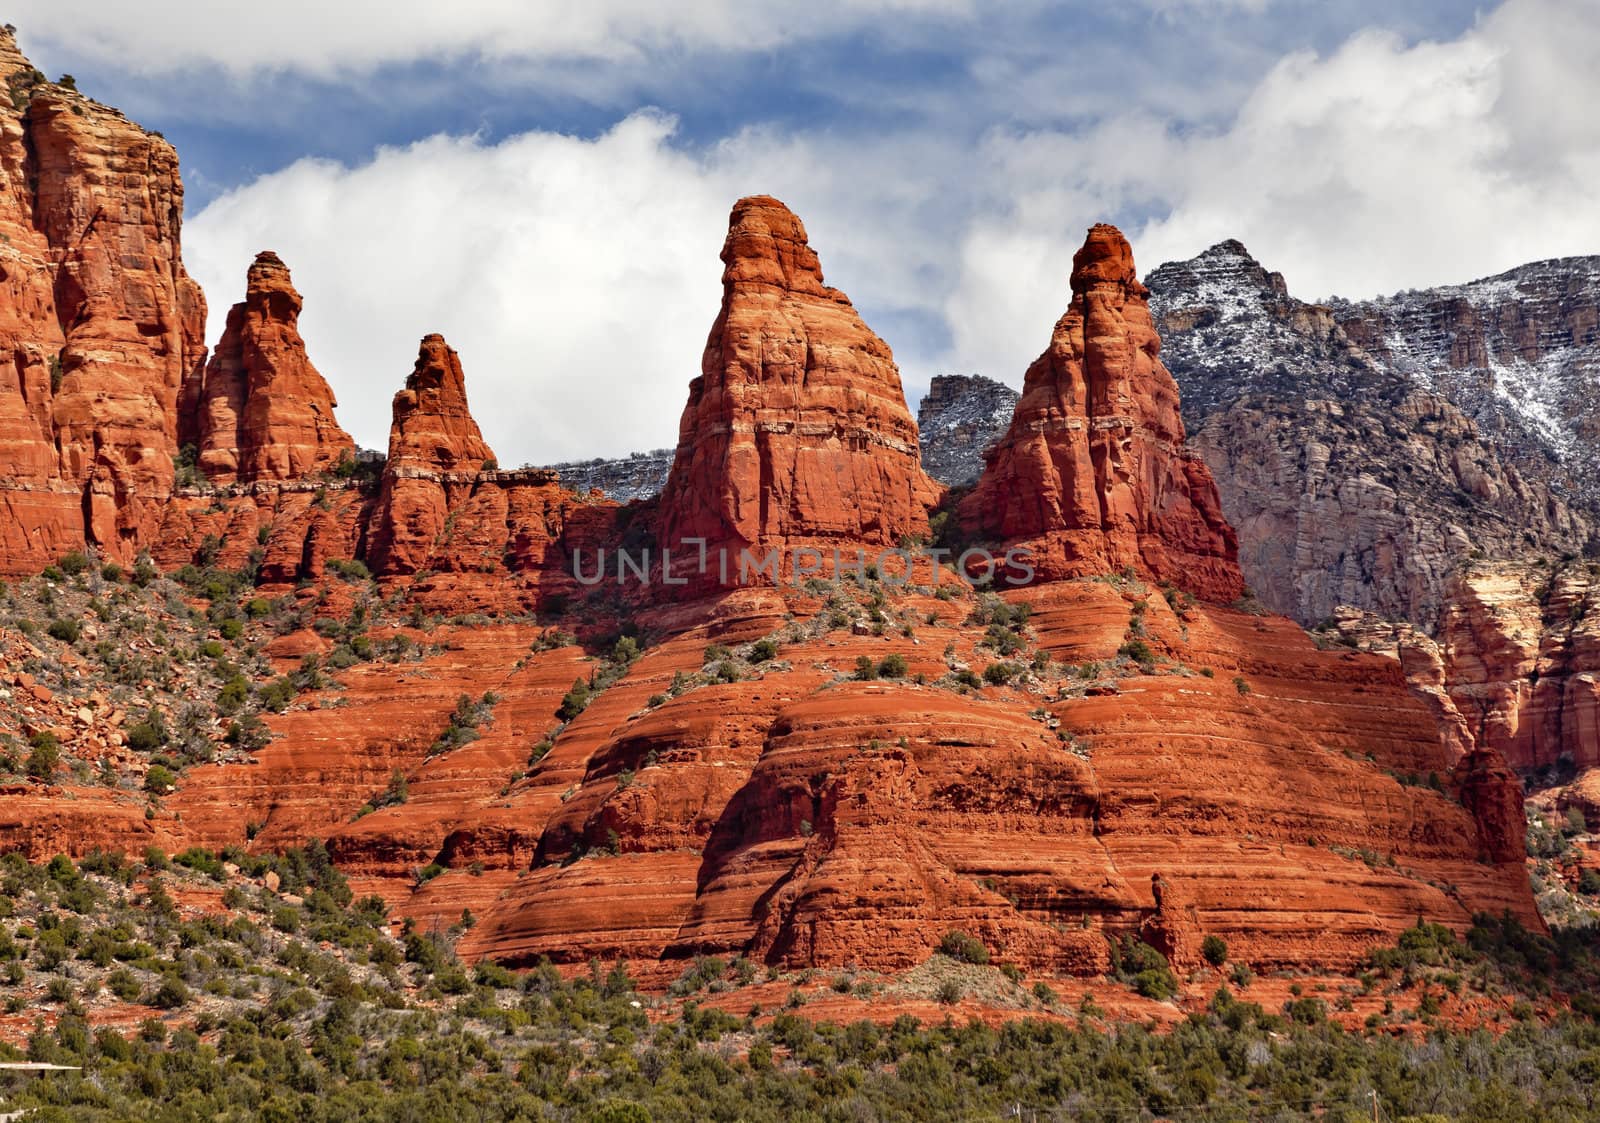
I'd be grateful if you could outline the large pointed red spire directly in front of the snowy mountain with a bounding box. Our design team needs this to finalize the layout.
[960,224,1243,601]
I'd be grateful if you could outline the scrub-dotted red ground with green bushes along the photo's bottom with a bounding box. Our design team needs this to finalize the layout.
[0,846,1600,1123]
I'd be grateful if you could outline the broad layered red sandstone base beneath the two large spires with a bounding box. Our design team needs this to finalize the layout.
[454,581,1538,974]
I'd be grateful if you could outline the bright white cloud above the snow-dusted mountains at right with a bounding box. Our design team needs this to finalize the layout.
[942,0,1600,381]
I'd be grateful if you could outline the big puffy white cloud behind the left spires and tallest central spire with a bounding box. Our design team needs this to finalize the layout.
[184,112,933,464]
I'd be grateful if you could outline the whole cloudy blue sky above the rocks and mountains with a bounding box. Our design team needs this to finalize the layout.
[10,0,1600,464]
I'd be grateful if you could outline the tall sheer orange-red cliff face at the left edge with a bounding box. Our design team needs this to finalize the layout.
[0,34,205,571]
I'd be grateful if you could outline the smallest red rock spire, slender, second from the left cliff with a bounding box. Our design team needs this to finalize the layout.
[366,334,494,574]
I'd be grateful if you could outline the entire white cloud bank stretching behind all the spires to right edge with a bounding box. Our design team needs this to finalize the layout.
[186,0,1600,462]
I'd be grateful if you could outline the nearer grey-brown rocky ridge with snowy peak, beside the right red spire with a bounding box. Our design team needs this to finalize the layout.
[1147,242,1595,630]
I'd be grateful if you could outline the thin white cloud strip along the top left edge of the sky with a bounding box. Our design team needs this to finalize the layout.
[10,0,971,77]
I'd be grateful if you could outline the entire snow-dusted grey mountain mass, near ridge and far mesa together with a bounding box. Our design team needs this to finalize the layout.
[1146,242,1600,630]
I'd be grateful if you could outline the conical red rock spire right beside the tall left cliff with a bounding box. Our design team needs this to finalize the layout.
[184,251,355,485]
